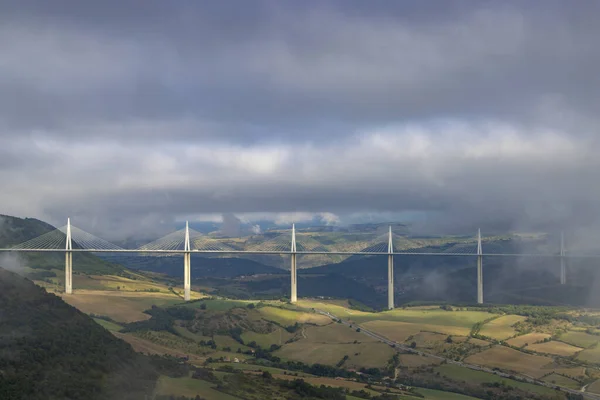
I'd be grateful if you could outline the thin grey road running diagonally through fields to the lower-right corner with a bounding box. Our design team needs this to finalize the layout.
[315,309,600,400]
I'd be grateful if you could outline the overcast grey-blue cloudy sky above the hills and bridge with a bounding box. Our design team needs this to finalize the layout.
[0,0,600,233]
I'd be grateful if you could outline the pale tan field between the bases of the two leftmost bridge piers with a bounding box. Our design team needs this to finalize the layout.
[62,290,182,322]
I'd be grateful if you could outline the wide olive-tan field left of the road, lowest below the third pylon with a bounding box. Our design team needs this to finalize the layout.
[274,340,394,368]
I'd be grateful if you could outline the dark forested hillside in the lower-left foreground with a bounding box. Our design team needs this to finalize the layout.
[0,268,157,400]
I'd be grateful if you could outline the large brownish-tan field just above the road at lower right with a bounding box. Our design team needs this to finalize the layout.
[465,346,552,378]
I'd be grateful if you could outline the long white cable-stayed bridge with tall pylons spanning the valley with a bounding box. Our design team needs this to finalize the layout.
[0,219,584,309]
